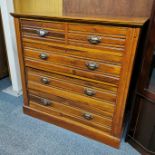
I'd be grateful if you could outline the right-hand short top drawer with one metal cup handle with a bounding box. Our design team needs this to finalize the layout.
[68,23,128,52]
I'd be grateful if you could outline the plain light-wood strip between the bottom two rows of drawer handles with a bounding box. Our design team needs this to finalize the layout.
[27,74,115,116]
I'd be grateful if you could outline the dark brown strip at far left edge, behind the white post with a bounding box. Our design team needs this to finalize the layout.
[0,12,8,79]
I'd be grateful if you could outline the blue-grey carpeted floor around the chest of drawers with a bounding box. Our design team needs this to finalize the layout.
[0,78,140,155]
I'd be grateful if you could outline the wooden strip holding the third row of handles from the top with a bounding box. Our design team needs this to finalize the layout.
[27,69,116,104]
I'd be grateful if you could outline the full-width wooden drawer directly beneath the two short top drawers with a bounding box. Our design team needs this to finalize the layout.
[24,49,121,87]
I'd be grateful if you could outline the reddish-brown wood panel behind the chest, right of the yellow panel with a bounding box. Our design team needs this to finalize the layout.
[63,0,153,17]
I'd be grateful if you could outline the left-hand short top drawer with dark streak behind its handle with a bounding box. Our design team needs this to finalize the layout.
[21,19,65,43]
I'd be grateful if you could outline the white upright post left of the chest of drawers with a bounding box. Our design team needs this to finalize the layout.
[0,0,22,94]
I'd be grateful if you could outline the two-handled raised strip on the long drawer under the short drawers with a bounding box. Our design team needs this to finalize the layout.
[24,49,121,76]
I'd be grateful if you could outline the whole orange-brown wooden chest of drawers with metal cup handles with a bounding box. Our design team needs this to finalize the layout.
[12,13,146,147]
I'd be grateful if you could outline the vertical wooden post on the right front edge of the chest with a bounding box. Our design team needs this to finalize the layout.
[113,28,140,137]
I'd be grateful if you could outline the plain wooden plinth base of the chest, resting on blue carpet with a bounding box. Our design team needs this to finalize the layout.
[24,106,120,147]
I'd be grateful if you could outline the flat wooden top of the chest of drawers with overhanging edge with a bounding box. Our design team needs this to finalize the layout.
[11,12,148,27]
